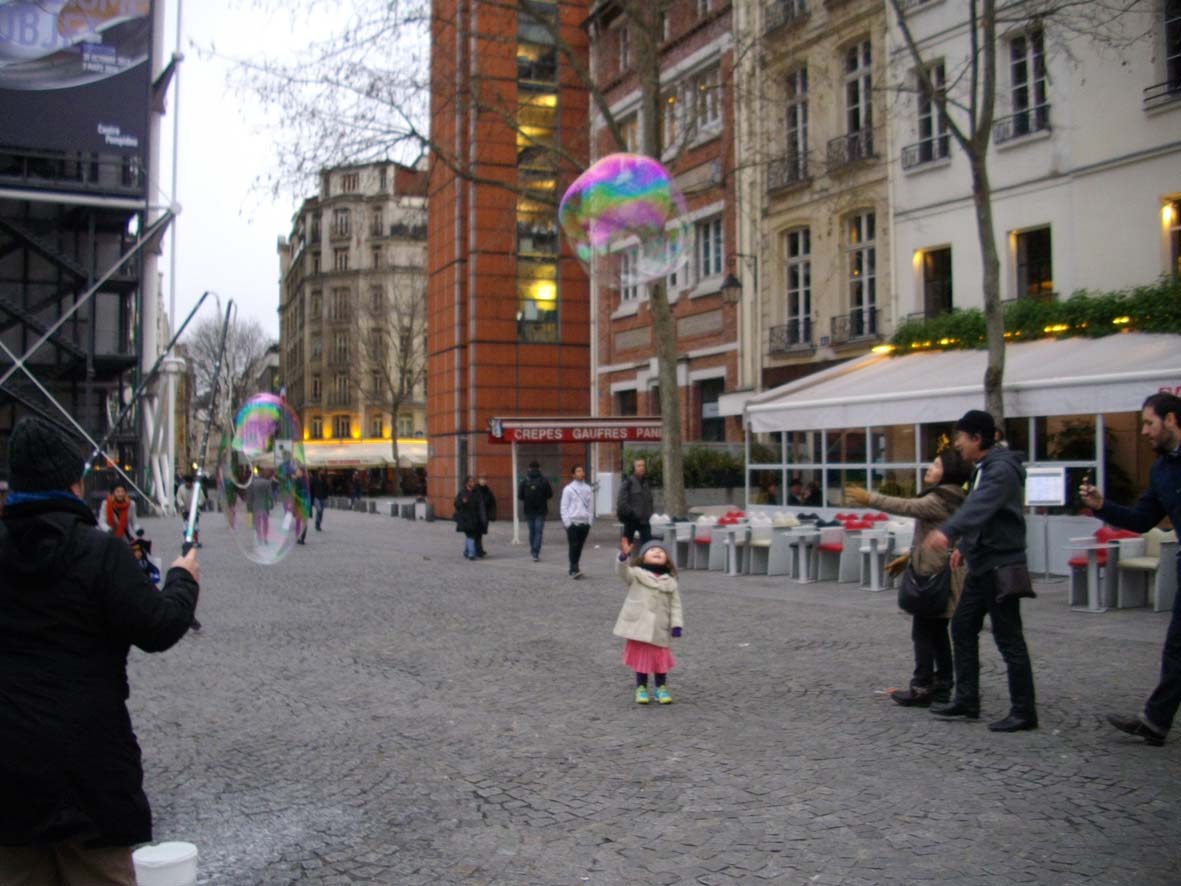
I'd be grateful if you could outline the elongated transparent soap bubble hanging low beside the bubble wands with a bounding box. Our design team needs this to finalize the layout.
[217,393,311,565]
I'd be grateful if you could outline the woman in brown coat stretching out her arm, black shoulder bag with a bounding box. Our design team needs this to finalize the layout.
[844,449,972,708]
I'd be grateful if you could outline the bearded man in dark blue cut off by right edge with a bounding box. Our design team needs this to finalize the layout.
[1078,393,1181,747]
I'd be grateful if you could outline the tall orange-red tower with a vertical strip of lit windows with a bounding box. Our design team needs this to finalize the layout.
[426,0,591,516]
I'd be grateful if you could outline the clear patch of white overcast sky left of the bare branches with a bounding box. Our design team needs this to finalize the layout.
[159,0,318,339]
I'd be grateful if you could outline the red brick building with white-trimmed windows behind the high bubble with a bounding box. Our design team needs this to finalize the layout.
[588,0,749,470]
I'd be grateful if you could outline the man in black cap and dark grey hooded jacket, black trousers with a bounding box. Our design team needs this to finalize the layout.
[924,409,1037,732]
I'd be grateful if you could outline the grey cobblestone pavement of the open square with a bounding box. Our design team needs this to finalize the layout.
[131,512,1181,886]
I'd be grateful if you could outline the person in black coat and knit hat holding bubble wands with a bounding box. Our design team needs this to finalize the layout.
[0,418,198,886]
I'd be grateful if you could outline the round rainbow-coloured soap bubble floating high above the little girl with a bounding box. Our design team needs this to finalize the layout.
[557,154,689,287]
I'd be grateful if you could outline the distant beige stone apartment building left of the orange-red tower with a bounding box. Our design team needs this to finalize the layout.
[279,162,426,480]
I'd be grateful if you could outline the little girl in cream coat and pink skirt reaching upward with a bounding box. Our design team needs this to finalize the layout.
[613,539,683,704]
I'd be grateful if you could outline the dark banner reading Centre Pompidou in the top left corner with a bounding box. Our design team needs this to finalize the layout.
[0,0,152,163]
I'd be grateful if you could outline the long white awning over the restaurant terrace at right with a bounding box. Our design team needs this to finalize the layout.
[719,333,1181,432]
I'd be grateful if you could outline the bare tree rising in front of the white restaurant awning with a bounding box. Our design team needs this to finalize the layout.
[889,0,1146,423]
